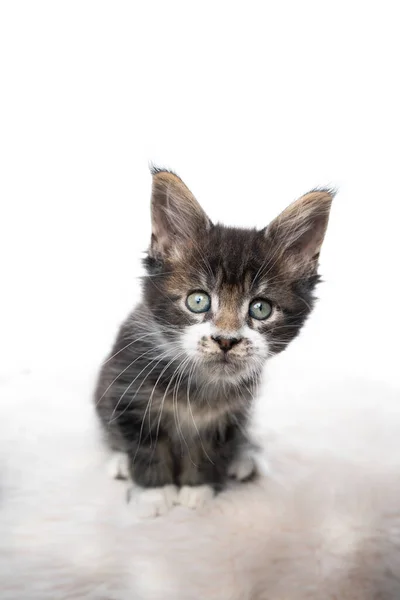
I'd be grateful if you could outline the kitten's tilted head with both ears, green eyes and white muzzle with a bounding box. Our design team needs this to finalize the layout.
[144,169,333,382]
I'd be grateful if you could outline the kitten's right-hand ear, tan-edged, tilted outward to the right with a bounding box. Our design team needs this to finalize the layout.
[264,189,335,272]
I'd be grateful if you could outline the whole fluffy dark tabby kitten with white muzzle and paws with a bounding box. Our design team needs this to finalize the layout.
[95,168,333,515]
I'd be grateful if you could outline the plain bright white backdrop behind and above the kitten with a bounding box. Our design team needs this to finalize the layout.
[0,0,400,383]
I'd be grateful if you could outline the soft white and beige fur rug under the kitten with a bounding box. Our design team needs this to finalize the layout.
[0,358,400,600]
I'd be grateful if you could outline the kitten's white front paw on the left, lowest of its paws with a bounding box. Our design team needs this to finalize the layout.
[129,485,178,519]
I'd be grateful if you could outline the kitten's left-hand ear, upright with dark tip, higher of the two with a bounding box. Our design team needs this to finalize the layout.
[150,169,212,257]
